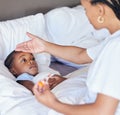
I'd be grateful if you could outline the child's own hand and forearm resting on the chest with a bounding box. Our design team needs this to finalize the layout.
[48,74,66,89]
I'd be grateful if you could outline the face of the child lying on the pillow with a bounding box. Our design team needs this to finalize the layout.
[11,52,38,76]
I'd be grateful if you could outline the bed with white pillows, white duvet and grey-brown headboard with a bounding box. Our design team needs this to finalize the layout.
[0,0,108,115]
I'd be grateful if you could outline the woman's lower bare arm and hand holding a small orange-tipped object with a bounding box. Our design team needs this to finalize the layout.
[33,85,119,115]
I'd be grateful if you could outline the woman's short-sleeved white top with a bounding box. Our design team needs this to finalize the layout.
[86,31,120,115]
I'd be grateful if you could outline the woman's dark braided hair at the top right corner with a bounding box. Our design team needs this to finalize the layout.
[91,0,120,20]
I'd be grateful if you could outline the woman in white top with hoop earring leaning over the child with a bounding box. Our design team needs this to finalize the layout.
[16,0,120,115]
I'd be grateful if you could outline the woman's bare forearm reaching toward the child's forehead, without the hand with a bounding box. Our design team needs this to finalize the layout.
[45,42,92,64]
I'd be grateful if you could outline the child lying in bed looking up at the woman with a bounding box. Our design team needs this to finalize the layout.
[4,51,65,92]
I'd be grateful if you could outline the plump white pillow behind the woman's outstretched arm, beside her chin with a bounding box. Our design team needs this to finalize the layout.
[45,5,110,67]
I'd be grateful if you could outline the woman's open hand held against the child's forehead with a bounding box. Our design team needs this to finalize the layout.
[15,32,45,53]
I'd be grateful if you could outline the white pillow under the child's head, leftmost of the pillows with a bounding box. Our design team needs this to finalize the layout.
[0,13,50,66]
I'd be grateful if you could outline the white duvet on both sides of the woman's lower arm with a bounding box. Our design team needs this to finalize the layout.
[0,68,87,115]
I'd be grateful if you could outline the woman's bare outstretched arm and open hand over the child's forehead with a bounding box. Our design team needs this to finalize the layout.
[16,33,92,64]
